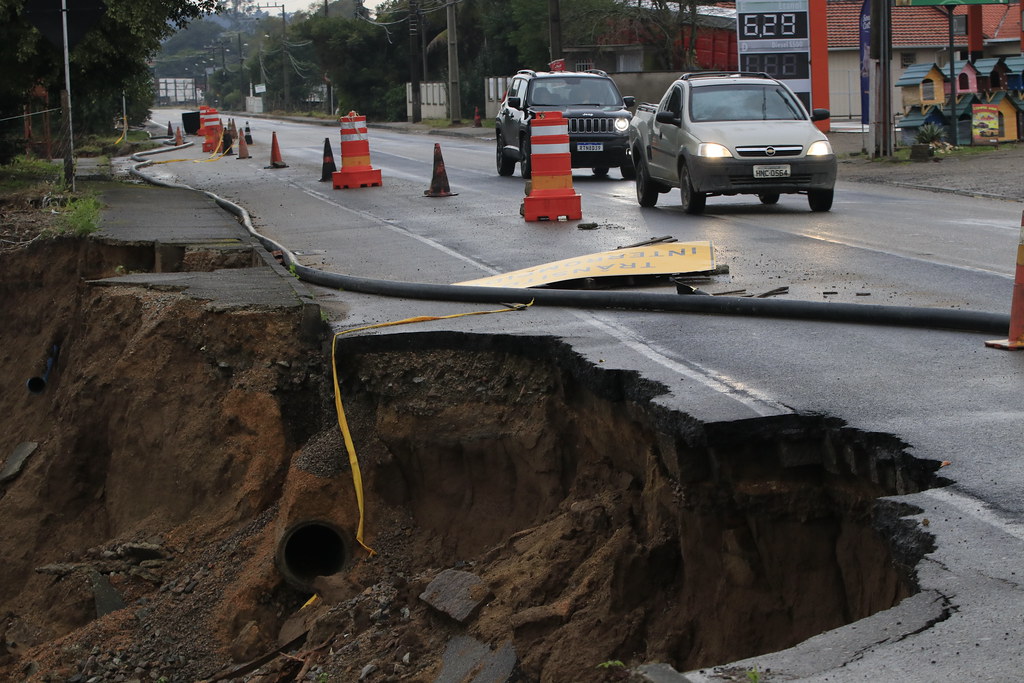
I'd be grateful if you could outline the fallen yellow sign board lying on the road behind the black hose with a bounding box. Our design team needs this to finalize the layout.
[456,242,715,289]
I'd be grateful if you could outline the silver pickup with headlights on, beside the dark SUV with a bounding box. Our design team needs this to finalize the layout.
[630,72,837,214]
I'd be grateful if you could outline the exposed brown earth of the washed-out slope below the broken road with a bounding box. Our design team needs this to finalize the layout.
[0,232,936,681]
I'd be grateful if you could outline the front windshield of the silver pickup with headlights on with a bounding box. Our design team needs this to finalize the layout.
[690,84,807,121]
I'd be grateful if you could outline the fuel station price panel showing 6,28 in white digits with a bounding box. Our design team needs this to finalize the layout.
[736,0,811,110]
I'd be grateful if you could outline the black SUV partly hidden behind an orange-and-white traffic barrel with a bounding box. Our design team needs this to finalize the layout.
[495,69,636,180]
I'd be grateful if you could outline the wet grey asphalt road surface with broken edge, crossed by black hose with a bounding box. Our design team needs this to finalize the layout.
[148,112,1024,682]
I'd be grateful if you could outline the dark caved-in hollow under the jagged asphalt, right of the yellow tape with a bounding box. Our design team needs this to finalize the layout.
[338,333,941,680]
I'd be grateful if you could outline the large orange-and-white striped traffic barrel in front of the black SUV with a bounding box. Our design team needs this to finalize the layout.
[523,112,583,221]
